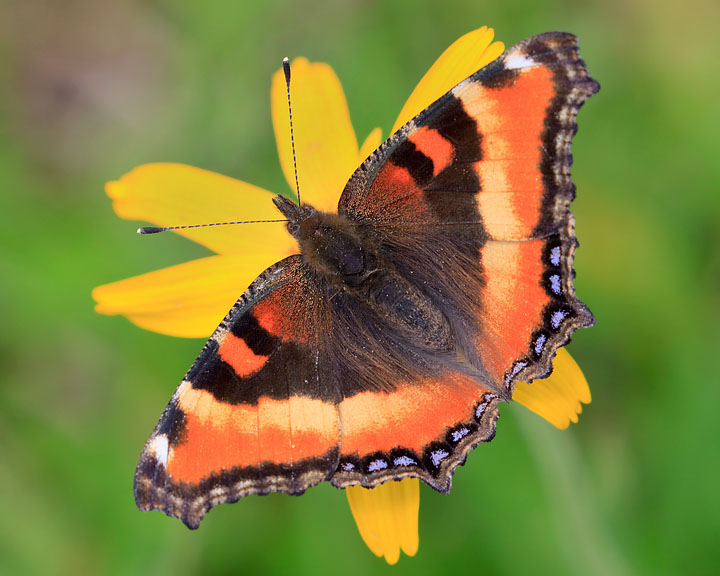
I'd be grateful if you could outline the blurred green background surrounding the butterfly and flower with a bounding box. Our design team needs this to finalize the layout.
[0,0,720,576]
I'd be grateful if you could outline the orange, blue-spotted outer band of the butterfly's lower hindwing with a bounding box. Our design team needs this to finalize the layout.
[331,369,498,493]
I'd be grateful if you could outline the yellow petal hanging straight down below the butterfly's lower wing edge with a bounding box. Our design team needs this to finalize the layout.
[346,478,420,564]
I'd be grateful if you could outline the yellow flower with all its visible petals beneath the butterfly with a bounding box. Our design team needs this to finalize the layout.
[93,27,590,564]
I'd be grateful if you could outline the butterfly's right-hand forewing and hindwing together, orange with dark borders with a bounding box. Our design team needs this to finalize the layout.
[339,32,599,392]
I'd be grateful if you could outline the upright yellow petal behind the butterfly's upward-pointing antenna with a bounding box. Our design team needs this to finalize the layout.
[271,58,362,212]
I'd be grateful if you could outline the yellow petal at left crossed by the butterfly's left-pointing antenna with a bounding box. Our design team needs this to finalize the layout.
[106,164,298,255]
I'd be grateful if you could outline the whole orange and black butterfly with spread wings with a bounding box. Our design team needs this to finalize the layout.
[134,32,599,528]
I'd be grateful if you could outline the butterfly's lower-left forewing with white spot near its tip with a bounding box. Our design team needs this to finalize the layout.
[135,255,340,528]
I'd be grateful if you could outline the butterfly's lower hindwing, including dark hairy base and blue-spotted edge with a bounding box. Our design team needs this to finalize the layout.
[316,276,503,492]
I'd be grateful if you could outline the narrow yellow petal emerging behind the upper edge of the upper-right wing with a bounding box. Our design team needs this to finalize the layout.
[392,26,505,132]
